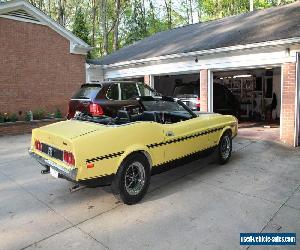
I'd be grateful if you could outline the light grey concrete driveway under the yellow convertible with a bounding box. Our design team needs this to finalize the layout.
[0,135,300,249]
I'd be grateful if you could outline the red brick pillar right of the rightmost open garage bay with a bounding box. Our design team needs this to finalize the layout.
[280,63,296,145]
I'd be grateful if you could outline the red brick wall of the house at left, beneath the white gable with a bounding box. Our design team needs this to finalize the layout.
[0,18,85,117]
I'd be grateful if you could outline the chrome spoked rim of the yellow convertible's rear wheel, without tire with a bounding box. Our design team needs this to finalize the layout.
[125,162,146,195]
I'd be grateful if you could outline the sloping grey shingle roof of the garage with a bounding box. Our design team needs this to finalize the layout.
[95,2,300,65]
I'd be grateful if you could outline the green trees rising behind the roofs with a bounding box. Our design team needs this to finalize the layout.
[1,0,296,58]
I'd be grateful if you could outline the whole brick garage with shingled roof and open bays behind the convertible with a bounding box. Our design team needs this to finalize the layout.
[89,2,300,146]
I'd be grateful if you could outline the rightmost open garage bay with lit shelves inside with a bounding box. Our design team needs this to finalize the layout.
[213,67,281,141]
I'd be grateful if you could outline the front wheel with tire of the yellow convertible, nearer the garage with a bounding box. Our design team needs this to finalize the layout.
[217,131,232,165]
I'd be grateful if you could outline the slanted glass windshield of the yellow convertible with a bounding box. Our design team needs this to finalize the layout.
[140,97,196,118]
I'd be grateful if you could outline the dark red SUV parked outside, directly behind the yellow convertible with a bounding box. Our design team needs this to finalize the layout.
[68,81,160,119]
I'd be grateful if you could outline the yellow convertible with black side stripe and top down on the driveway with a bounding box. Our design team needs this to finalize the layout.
[29,97,237,204]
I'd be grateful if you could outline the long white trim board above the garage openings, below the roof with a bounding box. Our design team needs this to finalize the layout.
[104,48,296,79]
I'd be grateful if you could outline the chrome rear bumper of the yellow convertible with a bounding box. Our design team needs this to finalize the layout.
[28,149,77,182]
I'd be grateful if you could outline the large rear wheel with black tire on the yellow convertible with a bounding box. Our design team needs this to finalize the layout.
[112,153,151,205]
